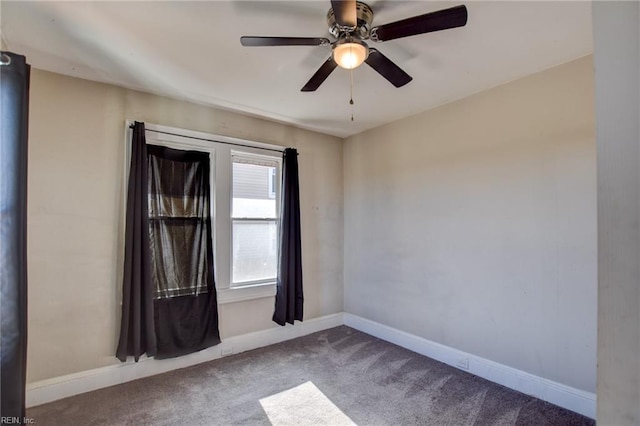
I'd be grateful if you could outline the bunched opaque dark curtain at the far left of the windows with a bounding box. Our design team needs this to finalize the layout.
[116,122,156,362]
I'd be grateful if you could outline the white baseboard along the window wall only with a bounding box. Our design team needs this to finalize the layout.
[26,313,344,407]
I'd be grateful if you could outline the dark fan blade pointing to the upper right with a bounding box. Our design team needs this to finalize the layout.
[370,5,467,41]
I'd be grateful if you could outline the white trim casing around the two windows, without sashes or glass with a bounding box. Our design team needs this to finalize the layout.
[122,120,284,305]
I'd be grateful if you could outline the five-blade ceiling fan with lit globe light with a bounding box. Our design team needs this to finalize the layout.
[240,0,467,92]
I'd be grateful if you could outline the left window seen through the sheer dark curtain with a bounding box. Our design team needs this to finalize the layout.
[147,144,214,299]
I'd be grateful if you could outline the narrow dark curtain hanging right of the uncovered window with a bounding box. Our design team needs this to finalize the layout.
[273,148,304,325]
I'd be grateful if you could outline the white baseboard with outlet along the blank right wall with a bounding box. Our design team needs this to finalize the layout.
[344,313,596,419]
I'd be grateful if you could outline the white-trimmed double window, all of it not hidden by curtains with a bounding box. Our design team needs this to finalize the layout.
[123,123,282,304]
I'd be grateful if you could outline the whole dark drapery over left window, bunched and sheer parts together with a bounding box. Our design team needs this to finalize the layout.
[116,122,220,361]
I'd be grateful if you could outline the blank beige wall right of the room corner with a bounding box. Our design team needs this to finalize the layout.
[343,57,597,392]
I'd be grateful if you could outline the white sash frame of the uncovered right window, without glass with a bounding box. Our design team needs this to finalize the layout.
[229,149,282,289]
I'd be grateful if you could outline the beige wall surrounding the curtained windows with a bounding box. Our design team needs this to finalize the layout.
[27,69,343,382]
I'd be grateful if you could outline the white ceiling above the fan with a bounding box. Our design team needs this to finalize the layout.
[0,0,593,137]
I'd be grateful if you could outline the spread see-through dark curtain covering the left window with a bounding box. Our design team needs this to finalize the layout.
[147,145,220,359]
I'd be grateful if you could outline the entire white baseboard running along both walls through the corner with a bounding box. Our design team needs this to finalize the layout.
[26,313,596,419]
